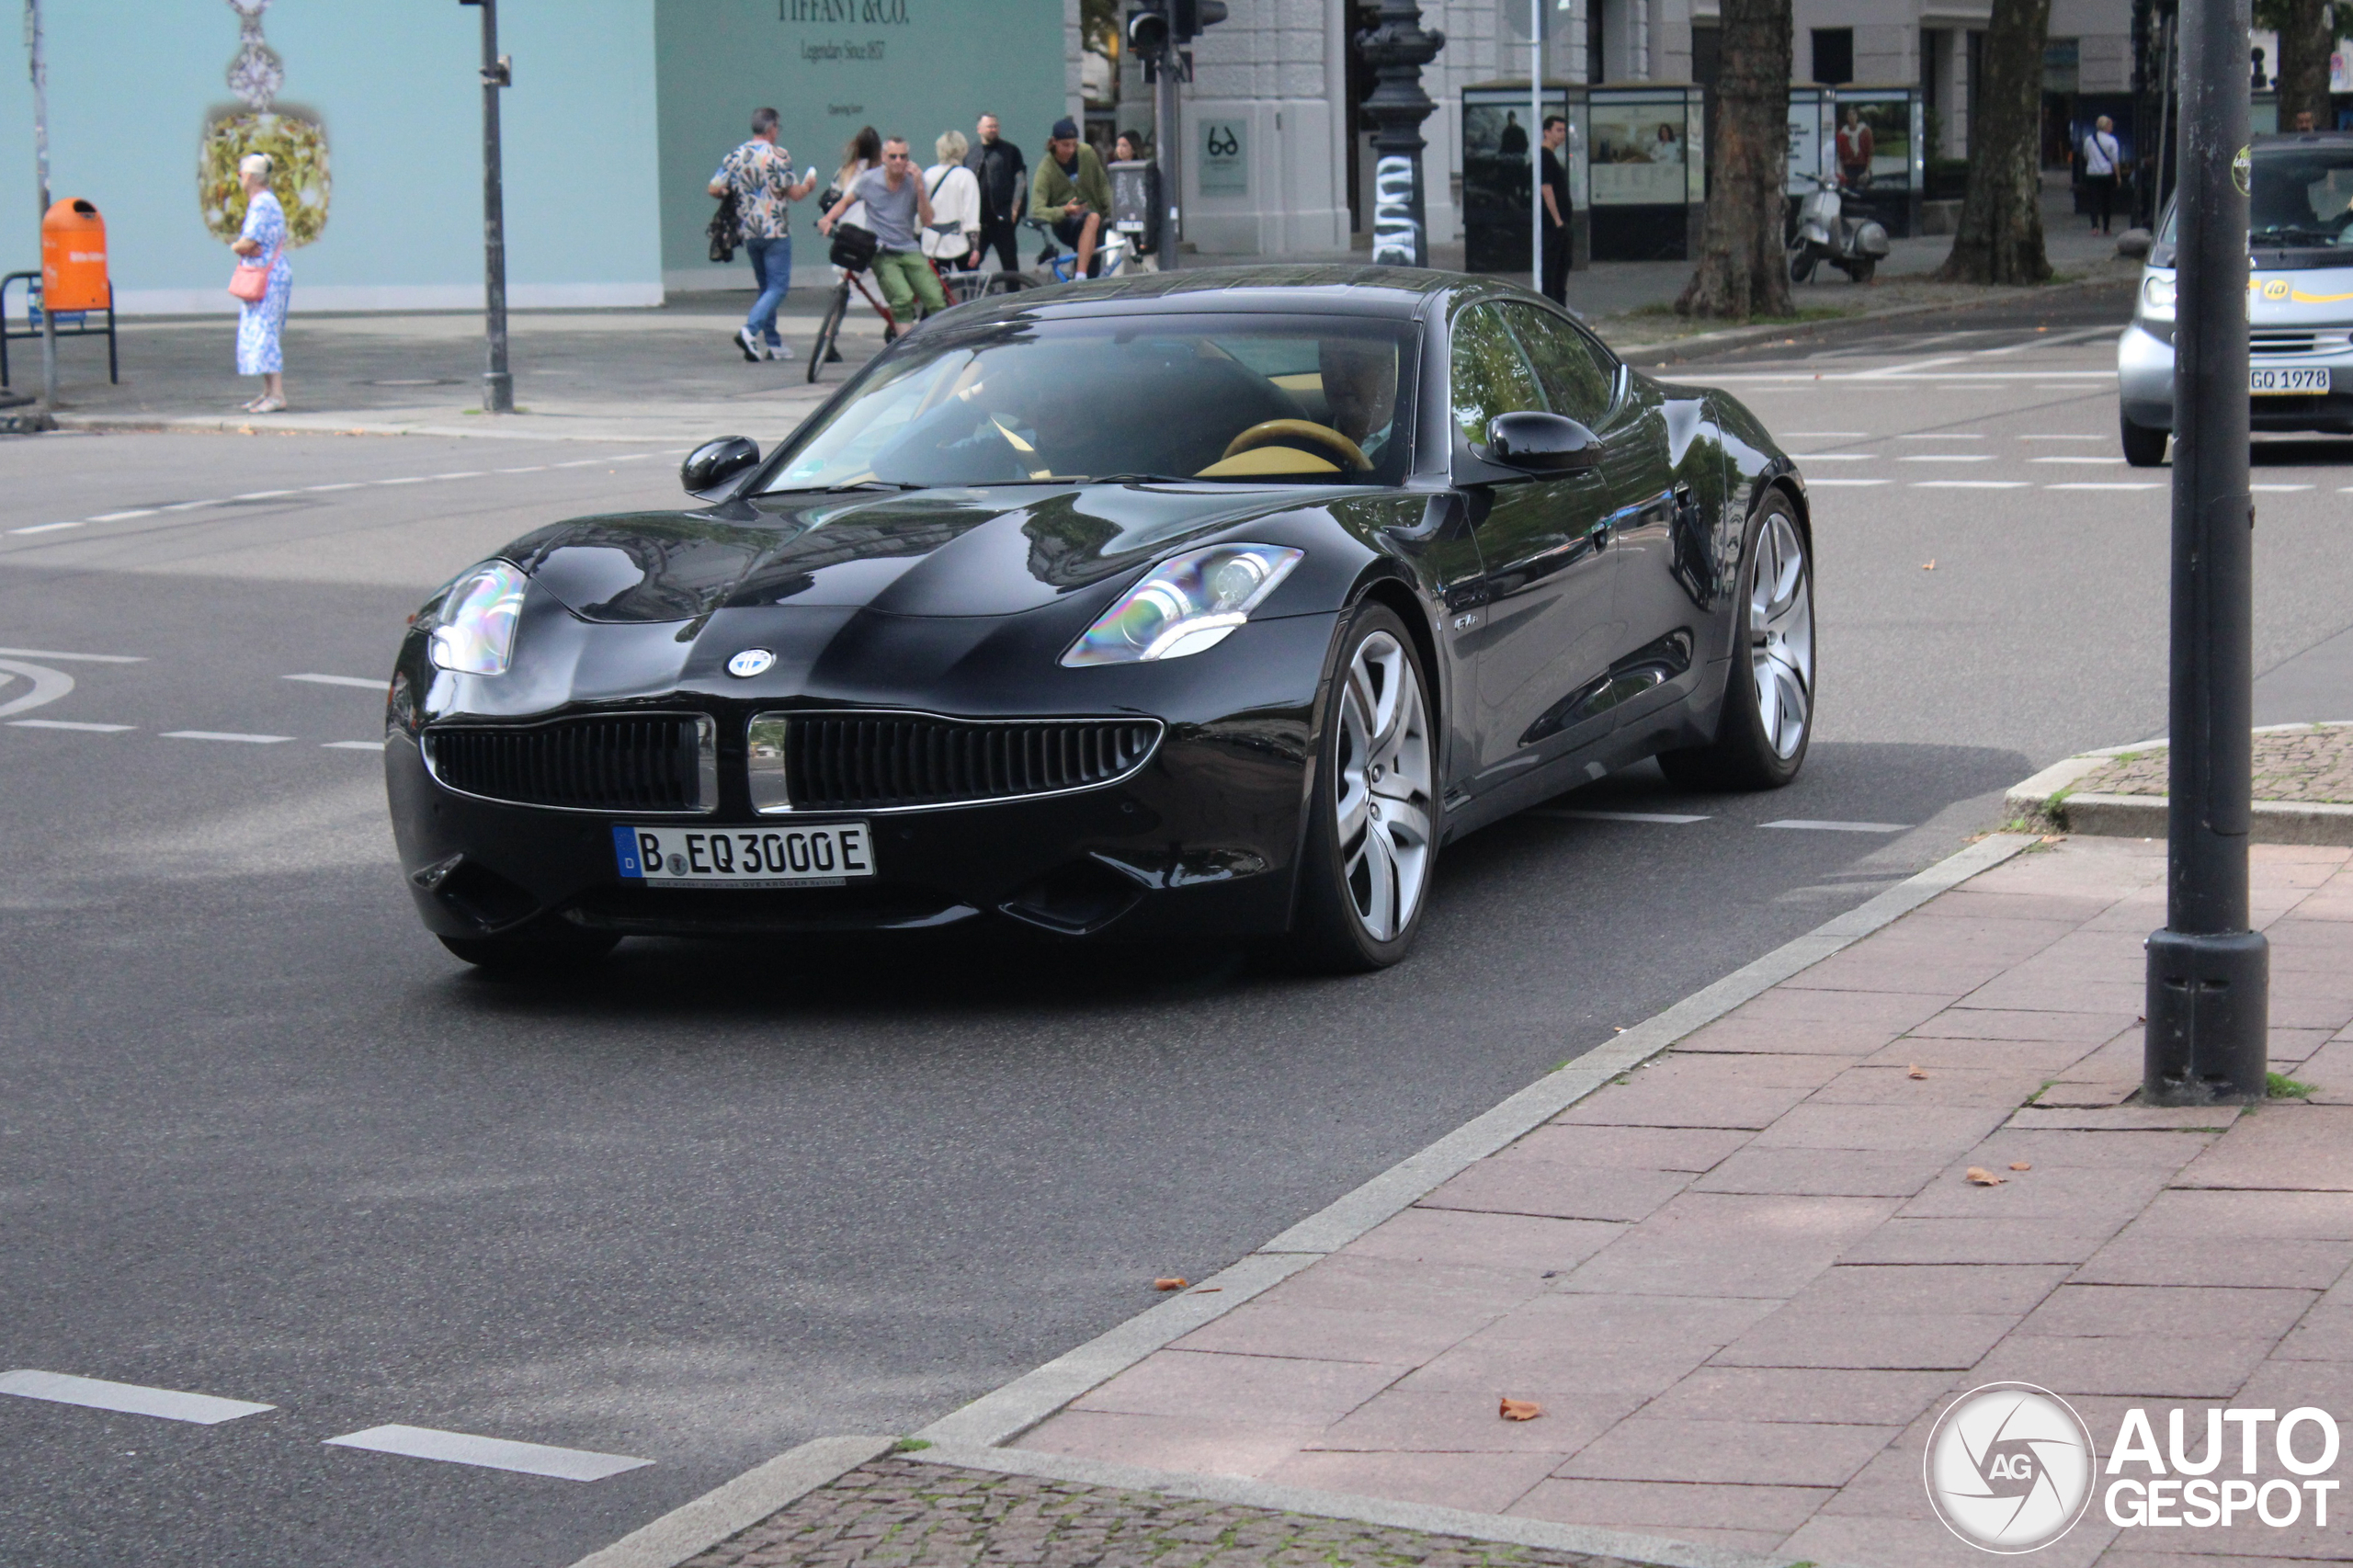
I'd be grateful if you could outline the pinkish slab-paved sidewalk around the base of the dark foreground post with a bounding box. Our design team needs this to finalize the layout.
[1021,838,2353,1568]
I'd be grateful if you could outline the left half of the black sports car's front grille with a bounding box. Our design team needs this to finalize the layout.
[424,713,718,812]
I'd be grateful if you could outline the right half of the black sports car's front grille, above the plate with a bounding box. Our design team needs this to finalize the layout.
[751,713,1160,812]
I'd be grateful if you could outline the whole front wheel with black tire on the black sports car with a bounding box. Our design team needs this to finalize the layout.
[1291,600,1438,974]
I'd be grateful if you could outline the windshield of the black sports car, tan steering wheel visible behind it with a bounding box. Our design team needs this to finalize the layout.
[765,315,1415,494]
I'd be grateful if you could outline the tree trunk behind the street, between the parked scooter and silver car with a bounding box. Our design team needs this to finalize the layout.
[1937,0,2052,282]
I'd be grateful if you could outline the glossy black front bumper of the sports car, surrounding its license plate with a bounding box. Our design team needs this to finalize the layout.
[386,617,1332,939]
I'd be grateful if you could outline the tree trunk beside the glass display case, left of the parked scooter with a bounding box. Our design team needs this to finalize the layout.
[1676,0,1790,320]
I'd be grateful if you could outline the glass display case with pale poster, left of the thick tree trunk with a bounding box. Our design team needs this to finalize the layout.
[1586,83,1709,261]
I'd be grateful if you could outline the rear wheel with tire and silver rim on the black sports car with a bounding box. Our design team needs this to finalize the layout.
[1659,490,1816,789]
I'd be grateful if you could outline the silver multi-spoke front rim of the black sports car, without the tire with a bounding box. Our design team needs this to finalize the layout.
[1332,631,1436,942]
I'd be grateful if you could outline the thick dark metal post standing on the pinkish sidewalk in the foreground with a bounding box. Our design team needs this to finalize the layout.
[2142,0,2268,1104]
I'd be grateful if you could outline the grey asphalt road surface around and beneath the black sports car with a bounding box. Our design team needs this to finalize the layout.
[0,283,2353,1568]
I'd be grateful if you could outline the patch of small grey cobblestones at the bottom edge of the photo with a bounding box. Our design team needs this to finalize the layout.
[685,1458,1631,1568]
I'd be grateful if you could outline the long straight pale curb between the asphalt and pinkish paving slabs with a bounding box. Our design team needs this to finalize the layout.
[915,834,2035,1448]
